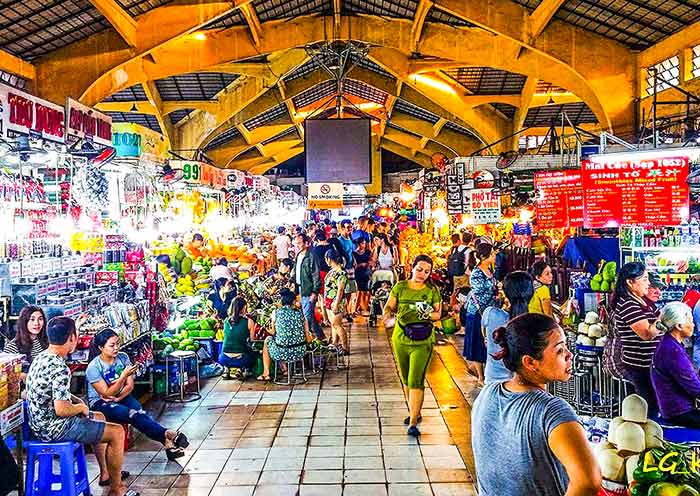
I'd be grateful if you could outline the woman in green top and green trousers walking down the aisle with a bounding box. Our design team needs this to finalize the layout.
[384,255,442,437]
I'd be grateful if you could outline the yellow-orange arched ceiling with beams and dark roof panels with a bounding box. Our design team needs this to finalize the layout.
[0,0,700,169]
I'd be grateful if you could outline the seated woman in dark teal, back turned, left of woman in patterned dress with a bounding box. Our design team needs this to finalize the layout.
[218,296,258,379]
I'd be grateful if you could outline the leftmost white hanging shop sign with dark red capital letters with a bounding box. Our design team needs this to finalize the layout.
[0,84,65,143]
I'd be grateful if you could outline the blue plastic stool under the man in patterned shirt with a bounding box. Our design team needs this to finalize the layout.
[24,441,90,496]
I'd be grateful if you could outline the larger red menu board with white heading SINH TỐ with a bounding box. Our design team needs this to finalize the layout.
[581,154,689,228]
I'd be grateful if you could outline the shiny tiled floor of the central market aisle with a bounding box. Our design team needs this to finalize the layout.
[83,324,476,496]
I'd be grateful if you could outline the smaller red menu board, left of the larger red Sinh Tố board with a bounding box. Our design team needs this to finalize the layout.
[535,170,583,229]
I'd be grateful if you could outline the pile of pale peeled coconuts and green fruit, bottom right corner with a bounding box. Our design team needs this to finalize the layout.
[594,394,700,496]
